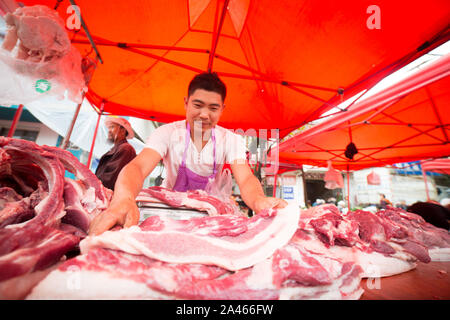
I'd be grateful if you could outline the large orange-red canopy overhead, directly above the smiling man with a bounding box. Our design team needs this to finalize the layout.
[23,0,450,136]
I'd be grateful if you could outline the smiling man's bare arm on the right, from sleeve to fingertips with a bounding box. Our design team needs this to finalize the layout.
[230,160,287,213]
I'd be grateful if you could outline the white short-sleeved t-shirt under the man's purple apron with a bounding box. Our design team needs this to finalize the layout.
[145,120,246,189]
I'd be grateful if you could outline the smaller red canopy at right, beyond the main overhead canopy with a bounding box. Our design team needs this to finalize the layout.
[280,54,450,170]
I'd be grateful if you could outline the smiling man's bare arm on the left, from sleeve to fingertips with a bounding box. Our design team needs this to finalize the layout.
[89,148,161,234]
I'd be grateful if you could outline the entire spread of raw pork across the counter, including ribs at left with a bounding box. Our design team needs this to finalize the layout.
[0,138,450,300]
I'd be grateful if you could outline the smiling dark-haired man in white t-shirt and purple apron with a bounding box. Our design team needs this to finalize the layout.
[89,73,287,234]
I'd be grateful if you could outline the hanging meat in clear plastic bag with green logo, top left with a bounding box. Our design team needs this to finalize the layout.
[0,6,87,105]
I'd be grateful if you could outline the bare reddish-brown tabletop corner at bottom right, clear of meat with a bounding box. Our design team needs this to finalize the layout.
[361,262,450,300]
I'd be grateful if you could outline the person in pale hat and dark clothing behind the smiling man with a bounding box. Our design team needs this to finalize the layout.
[95,117,136,190]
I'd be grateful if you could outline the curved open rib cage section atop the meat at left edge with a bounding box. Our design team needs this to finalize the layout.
[0,137,112,232]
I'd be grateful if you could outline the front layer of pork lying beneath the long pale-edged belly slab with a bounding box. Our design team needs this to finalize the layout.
[27,245,363,300]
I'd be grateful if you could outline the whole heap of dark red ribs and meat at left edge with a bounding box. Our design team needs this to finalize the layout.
[0,137,111,299]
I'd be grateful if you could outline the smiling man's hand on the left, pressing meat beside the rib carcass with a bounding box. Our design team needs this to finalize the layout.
[89,199,140,235]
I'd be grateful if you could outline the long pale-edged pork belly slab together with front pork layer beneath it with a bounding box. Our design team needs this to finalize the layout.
[27,200,370,300]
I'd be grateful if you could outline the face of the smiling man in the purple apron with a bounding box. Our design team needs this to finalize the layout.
[184,89,224,133]
